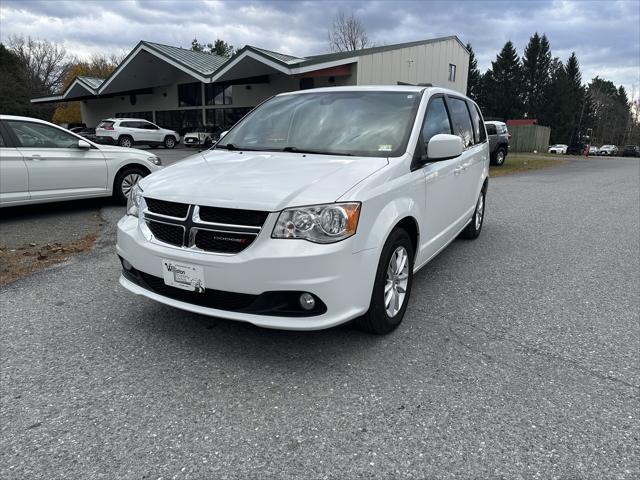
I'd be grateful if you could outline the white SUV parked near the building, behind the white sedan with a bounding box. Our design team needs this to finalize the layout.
[96,118,180,148]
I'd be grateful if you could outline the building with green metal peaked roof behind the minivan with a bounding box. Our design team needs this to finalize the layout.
[31,36,469,133]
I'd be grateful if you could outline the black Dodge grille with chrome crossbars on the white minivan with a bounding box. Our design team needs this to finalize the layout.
[144,202,269,255]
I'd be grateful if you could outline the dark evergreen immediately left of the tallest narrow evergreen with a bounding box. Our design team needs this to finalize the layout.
[483,41,523,120]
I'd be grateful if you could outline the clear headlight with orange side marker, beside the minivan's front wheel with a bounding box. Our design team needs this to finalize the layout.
[271,202,360,243]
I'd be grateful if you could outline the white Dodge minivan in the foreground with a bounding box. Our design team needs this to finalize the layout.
[117,86,489,333]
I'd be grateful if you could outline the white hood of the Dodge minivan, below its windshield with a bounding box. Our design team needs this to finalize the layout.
[140,150,388,211]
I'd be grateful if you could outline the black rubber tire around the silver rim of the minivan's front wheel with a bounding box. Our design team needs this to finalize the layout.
[355,228,414,335]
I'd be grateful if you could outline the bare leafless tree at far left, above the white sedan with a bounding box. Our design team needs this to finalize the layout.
[8,35,75,95]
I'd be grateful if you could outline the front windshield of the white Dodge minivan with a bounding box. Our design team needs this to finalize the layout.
[216,91,421,157]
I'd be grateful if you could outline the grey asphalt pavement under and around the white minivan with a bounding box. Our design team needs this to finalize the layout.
[0,156,640,479]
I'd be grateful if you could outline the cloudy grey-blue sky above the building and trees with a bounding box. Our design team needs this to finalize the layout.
[0,0,640,98]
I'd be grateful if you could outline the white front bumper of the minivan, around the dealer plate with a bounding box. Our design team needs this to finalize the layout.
[116,214,379,330]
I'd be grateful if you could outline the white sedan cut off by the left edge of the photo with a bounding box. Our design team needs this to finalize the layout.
[0,115,160,207]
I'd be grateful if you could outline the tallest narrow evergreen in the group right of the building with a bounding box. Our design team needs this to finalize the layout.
[522,32,551,118]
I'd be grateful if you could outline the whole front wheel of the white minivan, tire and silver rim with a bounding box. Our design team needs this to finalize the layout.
[355,228,414,335]
